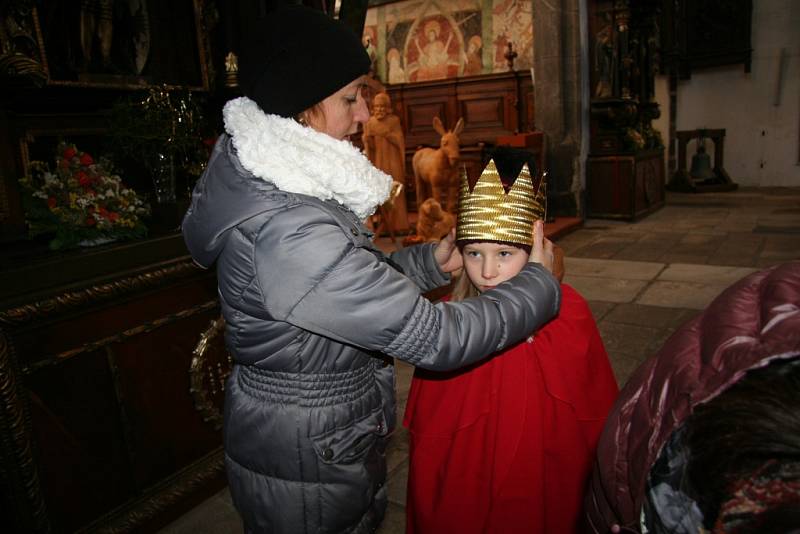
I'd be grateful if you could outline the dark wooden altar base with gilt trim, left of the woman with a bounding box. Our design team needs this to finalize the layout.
[0,234,226,532]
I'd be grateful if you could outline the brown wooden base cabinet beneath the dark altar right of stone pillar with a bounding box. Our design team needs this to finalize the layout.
[586,149,664,221]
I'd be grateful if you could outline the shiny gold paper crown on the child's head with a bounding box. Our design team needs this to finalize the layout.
[456,159,547,245]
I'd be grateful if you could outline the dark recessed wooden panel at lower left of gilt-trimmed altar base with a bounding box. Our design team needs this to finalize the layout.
[26,348,136,532]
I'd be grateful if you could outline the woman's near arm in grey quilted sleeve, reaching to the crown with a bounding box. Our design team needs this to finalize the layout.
[256,209,560,370]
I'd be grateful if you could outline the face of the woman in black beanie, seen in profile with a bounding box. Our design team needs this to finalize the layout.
[308,76,369,139]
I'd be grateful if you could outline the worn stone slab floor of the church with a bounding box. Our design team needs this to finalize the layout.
[160,188,800,534]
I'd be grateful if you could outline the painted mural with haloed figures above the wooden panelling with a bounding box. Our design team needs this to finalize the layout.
[363,0,533,84]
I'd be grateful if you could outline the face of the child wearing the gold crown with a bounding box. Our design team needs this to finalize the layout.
[462,243,528,293]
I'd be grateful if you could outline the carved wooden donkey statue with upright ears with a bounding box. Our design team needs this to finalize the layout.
[411,117,464,214]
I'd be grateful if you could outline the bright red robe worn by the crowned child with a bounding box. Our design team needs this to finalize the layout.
[404,285,618,534]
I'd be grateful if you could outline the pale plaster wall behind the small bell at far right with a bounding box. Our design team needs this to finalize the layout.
[676,0,800,186]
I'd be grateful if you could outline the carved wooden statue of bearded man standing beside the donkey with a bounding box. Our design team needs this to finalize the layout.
[363,92,408,232]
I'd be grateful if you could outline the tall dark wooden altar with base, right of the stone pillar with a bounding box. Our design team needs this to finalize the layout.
[586,0,665,220]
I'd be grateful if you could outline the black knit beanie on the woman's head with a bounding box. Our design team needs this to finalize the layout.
[238,5,370,117]
